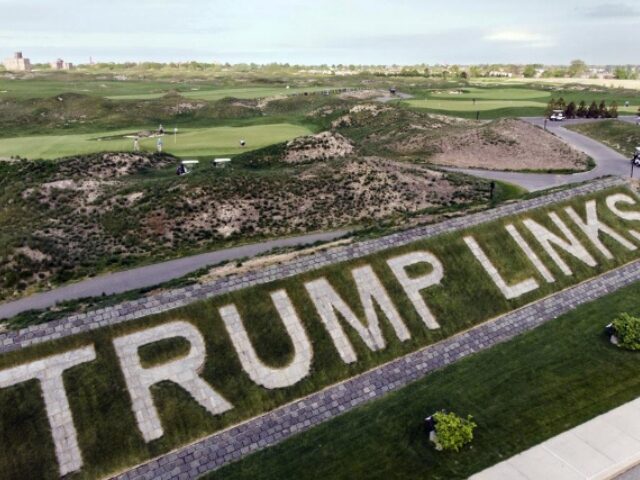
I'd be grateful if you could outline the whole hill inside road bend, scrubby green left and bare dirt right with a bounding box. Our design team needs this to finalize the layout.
[330,104,588,171]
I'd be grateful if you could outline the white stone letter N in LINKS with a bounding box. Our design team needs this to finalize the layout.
[522,212,597,275]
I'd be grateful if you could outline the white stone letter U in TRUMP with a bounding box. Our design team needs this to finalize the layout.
[219,290,313,388]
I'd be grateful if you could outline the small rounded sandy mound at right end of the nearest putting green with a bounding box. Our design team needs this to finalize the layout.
[283,132,354,163]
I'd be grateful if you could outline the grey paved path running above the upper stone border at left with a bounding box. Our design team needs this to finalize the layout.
[0,230,349,318]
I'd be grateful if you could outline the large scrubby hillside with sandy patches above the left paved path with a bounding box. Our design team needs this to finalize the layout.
[0,149,488,299]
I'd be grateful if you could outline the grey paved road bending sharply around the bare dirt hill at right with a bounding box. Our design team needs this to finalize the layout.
[447,117,640,190]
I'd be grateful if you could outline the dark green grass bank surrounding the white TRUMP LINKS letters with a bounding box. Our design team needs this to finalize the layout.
[0,186,637,478]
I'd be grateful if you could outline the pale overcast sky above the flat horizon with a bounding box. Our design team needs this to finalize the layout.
[0,0,640,64]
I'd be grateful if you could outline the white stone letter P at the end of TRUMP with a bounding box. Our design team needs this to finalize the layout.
[387,252,444,329]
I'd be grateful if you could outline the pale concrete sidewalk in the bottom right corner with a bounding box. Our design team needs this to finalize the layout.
[470,399,640,480]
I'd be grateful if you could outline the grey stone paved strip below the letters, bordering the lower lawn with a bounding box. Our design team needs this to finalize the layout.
[114,260,640,480]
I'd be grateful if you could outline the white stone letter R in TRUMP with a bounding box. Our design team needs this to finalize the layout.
[113,321,233,442]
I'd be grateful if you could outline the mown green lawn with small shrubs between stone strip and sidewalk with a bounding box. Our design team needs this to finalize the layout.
[205,284,640,480]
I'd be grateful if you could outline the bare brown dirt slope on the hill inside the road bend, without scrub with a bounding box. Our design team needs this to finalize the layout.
[404,119,588,170]
